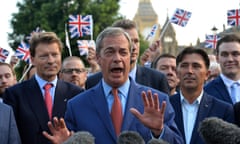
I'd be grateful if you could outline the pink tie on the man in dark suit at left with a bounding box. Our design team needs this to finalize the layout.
[44,83,52,120]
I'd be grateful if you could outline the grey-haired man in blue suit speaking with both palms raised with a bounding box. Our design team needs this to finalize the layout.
[44,27,183,144]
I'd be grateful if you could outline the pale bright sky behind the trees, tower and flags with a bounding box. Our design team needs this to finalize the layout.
[0,0,240,59]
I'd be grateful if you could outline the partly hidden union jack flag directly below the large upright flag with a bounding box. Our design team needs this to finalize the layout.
[77,40,95,56]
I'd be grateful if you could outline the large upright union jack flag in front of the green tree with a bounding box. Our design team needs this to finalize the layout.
[68,15,93,38]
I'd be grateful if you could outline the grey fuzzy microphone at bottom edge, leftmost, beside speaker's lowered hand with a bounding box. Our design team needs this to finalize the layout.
[63,131,95,144]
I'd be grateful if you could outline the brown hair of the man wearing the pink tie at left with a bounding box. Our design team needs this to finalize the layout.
[29,32,63,57]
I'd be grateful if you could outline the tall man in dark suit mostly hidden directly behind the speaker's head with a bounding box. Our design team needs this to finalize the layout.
[86,19,169,94]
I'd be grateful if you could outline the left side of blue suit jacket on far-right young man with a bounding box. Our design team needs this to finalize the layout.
[204,76,233,104]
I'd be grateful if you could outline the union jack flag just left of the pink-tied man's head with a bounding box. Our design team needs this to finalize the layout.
[15,41,30,64]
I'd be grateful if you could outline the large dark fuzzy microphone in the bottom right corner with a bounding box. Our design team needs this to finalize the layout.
[198,117,240,144]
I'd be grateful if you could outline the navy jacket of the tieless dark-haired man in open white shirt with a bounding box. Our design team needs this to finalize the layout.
[170,93,235,144]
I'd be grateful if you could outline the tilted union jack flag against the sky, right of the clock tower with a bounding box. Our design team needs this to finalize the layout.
[170,8,192,27]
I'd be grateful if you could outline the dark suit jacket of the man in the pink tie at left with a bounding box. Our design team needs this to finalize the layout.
[4,77,82,144]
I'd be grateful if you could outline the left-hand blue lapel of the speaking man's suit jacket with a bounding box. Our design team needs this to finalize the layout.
[89,81,117,140]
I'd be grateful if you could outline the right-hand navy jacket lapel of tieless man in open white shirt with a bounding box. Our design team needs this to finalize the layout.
[190,93,212,143]
